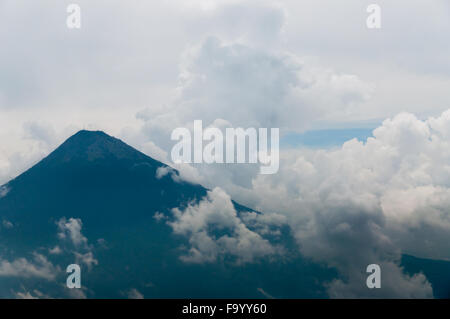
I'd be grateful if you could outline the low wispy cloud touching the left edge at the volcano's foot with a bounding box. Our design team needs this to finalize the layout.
[0,253,60,280]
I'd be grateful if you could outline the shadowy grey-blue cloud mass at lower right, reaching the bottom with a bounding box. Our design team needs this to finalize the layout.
[294,199,433,298]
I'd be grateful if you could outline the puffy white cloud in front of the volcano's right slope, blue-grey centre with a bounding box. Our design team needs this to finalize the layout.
[168,188,282,263]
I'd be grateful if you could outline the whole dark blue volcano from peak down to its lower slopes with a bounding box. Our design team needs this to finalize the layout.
[0,131,448,298]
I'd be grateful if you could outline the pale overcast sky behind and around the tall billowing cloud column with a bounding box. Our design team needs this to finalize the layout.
[0,0,450,136]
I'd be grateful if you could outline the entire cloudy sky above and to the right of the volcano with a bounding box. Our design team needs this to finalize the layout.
[0,0,450,297]
